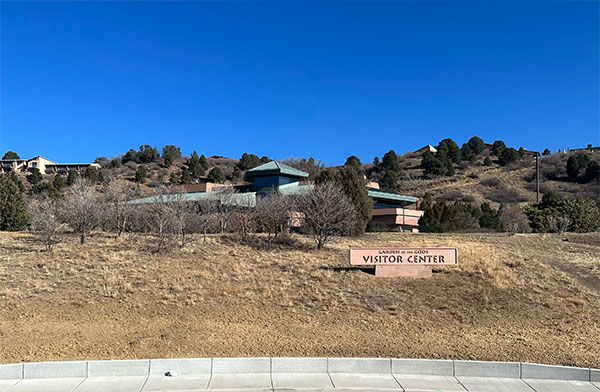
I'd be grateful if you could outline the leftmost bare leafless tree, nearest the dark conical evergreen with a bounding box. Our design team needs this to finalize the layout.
[29,196,63,252]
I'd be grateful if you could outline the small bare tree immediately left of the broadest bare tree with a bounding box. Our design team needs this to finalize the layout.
[256,192,291,245]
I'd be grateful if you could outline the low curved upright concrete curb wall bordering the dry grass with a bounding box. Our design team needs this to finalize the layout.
[0,358,600,382]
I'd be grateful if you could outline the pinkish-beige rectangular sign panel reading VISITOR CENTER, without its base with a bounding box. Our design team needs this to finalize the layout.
[350,248,458,266]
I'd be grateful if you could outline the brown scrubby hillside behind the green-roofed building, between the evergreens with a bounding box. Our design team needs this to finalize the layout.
[9,142,600,214]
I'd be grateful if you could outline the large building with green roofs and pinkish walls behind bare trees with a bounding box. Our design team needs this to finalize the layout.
[131,161,423,232]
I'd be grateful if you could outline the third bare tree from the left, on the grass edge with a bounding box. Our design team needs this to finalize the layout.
[102,180,137,237]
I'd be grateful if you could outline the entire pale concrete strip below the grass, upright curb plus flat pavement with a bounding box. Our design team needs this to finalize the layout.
[0,358,600,392]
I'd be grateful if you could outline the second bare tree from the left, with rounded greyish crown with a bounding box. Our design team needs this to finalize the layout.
[60,177,100,245]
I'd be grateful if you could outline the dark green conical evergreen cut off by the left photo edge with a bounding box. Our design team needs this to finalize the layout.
[0,175,29,231]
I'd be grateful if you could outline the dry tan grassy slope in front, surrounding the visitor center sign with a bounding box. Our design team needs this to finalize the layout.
[0,232,600,368]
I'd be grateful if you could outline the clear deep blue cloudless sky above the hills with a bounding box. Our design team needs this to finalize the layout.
[0,1,600,164]
